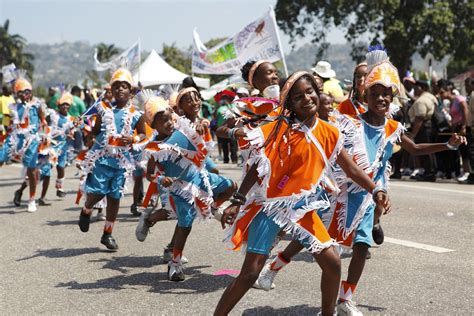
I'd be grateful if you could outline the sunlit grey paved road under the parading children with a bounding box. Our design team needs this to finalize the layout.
[0,165,474,315]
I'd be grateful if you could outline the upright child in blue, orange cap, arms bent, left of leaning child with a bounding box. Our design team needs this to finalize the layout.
[79,68,145,251]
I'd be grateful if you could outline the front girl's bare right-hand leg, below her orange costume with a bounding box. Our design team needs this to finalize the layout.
[313,246,340,315]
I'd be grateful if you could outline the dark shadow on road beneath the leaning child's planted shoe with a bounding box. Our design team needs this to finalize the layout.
[56,257,232,294]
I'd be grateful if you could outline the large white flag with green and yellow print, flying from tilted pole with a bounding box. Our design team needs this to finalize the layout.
[193,9,286,74]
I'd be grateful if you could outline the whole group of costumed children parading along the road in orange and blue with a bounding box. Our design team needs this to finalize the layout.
[0,47,466,315]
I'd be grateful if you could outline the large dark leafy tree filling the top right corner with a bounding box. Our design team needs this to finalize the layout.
[275,0,474,74]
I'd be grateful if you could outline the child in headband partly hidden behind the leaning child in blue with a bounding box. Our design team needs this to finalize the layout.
[157,87,237,263]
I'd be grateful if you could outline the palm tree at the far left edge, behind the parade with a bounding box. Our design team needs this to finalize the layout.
[0,20,34,77]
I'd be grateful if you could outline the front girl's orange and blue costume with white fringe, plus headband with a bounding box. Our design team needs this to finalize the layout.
[227,72,343,255]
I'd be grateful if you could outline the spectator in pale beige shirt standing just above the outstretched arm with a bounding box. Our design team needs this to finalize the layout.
[408,80,438,181]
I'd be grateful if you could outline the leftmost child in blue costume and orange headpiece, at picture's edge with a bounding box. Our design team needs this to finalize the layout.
[0,73,46,213]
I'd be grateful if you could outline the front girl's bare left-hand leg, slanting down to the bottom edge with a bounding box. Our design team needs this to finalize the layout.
[214,252,267,316]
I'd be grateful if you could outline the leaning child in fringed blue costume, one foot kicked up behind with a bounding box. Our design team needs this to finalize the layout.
[137,91,233,281]
